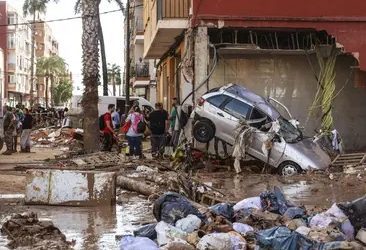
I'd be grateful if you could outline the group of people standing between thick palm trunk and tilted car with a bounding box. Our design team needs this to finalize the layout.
[101,98,179,158]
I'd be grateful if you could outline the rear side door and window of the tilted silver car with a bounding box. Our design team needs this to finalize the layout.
[221,97,252,145]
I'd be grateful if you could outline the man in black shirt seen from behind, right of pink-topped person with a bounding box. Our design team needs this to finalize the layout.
[147,103,169,157]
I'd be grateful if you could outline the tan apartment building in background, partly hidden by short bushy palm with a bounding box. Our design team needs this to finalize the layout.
[34,20,58,106]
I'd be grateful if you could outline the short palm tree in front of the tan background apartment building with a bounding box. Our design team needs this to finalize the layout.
[37,56,65,107]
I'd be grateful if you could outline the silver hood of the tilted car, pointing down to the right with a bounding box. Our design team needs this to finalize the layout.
[287,138,331,169]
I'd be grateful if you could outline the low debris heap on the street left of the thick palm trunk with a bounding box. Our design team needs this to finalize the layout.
[31,127,80,147]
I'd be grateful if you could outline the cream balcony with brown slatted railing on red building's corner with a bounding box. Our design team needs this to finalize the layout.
[144,0,191,59]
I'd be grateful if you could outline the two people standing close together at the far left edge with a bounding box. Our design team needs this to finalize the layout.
[3,106,33,155]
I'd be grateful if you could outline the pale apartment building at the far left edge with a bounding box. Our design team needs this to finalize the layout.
[0,1,31,106]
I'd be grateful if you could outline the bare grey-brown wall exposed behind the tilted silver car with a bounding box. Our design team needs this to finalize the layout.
[209,55,366,150]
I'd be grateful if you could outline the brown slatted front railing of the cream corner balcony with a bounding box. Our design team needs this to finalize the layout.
[157,0,191,20]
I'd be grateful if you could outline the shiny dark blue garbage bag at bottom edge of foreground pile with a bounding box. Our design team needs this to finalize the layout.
[256,226,319,250]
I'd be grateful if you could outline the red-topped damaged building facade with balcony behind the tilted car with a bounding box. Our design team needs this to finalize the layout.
[144,0,366,150]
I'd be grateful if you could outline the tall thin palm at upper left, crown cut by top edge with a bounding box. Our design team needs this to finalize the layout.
[23,0,57,105]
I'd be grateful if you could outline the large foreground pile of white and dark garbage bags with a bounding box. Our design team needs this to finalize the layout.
[120,190,366,250]
